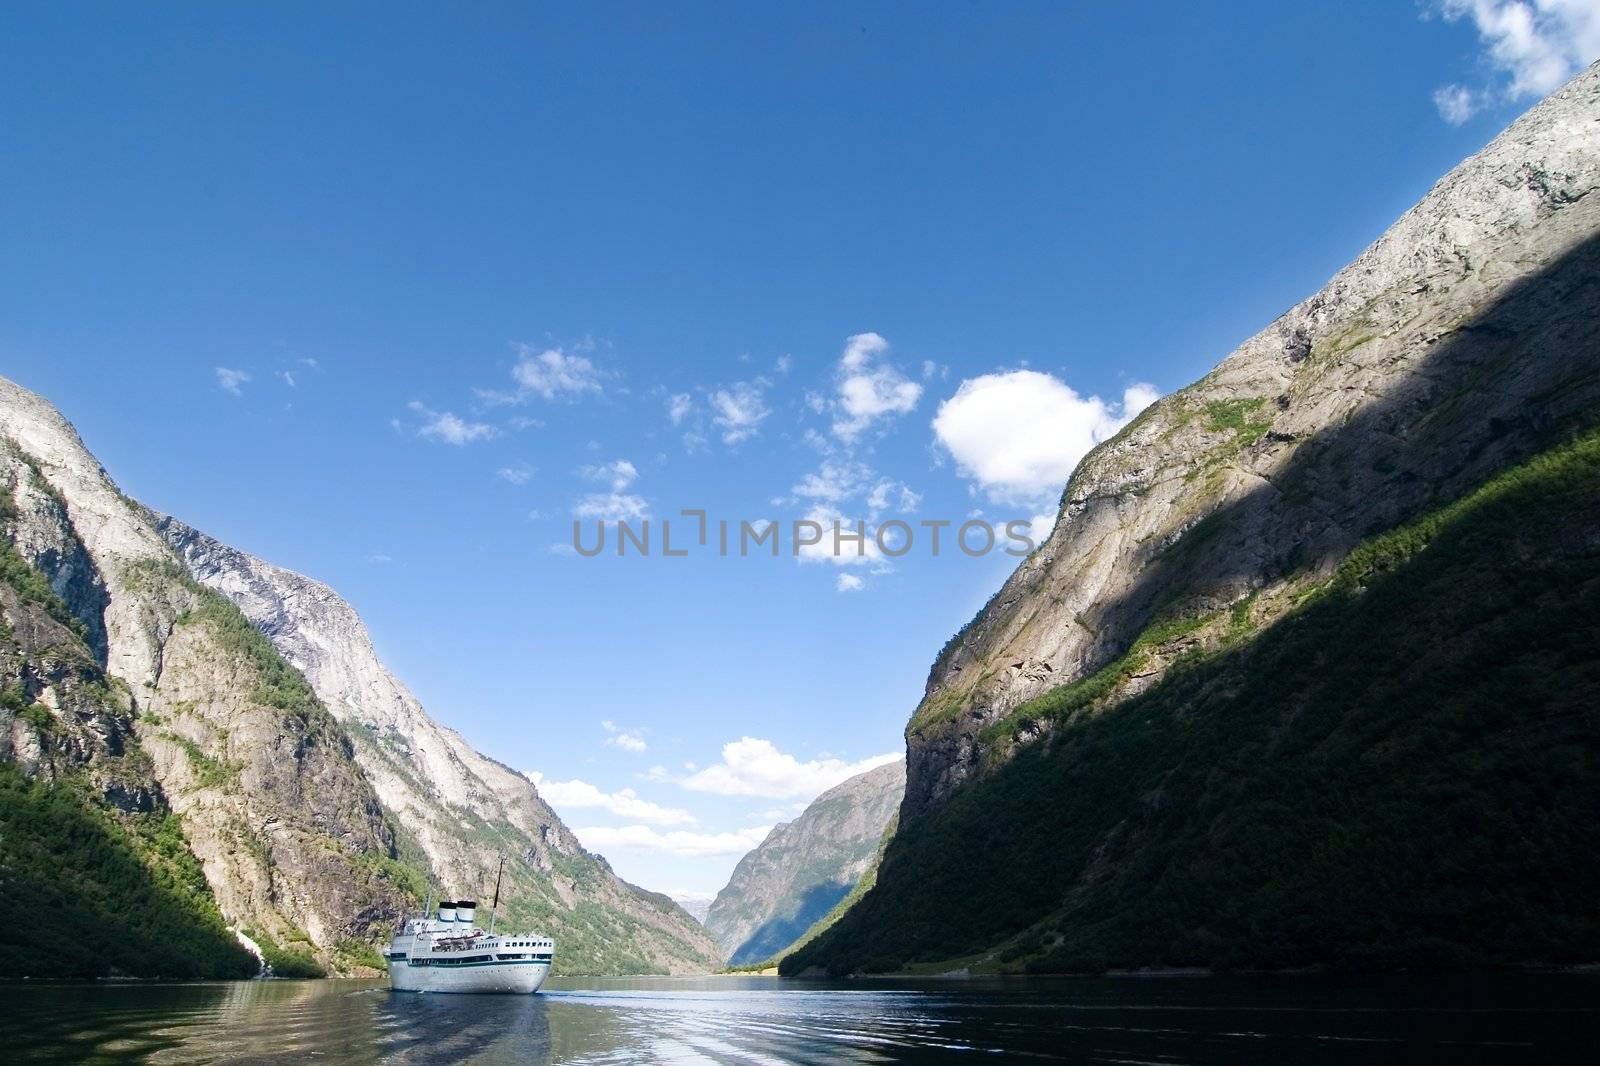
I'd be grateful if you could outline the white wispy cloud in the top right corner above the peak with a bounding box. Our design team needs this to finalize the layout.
[1434,0,1600,125]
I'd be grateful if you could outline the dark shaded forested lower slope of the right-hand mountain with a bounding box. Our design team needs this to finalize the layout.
[782,434,1600,973]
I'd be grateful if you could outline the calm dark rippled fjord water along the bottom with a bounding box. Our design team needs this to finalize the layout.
[0,975,1600,1066]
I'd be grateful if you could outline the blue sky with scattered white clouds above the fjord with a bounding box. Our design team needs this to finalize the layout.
[0,0,1600,893]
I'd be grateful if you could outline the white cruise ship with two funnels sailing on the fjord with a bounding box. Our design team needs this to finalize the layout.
[384,900,555,996]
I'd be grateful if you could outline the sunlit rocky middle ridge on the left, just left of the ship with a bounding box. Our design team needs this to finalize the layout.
[0,379,406,970]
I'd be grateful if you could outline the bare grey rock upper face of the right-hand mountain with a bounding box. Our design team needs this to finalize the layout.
[902,66,1600,820]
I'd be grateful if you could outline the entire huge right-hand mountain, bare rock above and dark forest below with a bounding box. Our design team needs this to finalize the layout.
[786,58,1600,973]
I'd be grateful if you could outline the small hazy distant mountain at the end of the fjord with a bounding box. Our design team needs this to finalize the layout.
[706,760,906,967]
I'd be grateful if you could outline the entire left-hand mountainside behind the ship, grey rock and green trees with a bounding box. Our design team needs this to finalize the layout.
[0,379,720,976]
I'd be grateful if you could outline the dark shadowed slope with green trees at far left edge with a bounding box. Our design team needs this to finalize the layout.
[0,485,258,978]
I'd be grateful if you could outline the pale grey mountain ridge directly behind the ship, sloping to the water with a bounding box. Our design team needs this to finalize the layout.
[158,519,720,973]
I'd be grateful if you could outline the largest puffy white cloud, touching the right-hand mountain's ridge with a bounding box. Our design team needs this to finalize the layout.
[933,370,1160,503]
